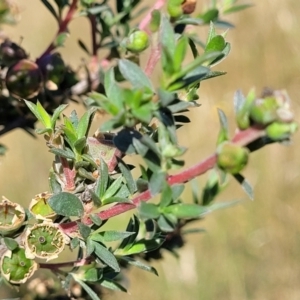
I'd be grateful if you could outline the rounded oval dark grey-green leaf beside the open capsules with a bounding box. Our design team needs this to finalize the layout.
[48,192,84,217]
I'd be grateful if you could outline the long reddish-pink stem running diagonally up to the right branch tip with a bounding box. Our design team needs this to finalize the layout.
[60,128,265,234]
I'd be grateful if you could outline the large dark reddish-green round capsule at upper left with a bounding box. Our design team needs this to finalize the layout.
[5,59,43,99]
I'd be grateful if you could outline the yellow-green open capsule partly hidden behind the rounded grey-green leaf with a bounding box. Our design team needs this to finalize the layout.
[29,192,57,221]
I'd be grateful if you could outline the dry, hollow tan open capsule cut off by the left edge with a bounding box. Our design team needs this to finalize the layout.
[0,197,26,235]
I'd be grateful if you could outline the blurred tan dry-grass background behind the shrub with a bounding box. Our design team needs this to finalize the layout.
[0,0,300,300]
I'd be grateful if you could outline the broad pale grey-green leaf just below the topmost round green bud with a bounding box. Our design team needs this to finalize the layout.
[118,59,154,92]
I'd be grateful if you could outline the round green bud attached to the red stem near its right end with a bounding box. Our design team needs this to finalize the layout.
[217,142,249,174]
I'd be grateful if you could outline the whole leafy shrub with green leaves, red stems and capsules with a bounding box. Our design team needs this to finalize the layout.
[0,0,297,299]
